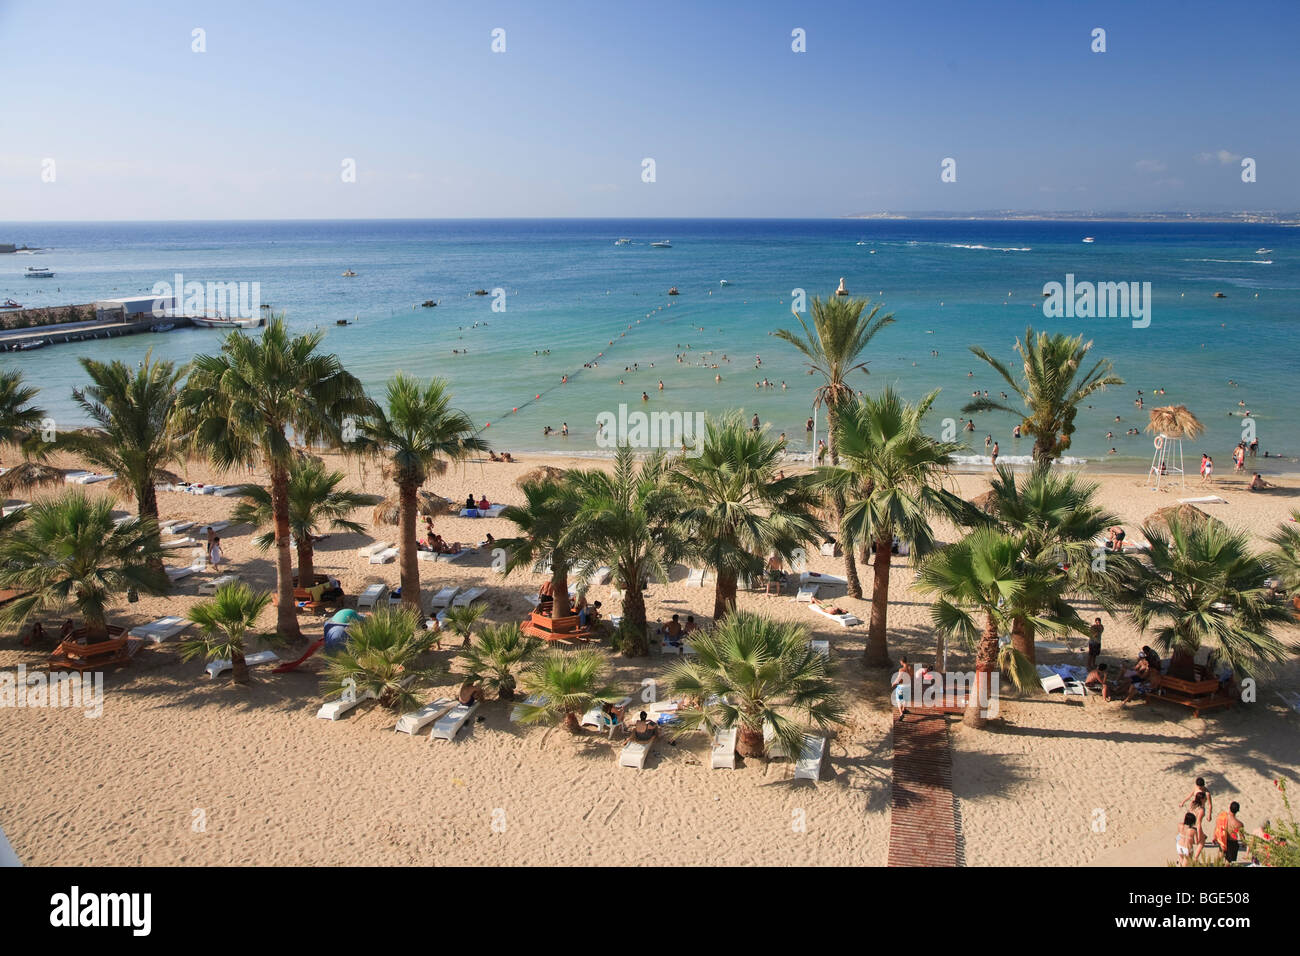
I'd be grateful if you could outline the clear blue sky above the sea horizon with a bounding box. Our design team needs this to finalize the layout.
[0,0,1300,218]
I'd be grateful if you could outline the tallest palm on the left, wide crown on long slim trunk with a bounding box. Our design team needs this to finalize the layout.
[177,316,374,640]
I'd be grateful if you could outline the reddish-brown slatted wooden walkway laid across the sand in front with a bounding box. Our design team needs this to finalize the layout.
[889,713,961,866]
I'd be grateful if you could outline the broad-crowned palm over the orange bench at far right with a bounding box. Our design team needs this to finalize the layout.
[1132,516,1294,680]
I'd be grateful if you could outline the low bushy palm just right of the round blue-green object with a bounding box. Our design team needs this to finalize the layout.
[325,606,441,710]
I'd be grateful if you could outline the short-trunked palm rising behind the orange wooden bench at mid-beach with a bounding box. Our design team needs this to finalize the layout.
[497,475,581,620]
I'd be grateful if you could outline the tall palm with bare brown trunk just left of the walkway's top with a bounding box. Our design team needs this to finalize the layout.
[818,388,966,667]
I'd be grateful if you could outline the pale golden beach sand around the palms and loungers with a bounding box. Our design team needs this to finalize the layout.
[0,455,1300,866]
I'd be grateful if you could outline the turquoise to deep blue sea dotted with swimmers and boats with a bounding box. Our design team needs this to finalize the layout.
[0,220,1300,472]
